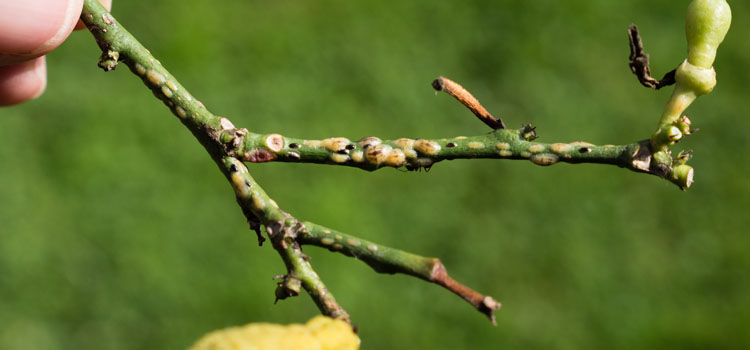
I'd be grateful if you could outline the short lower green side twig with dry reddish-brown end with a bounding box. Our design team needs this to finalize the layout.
[298,222,500,324]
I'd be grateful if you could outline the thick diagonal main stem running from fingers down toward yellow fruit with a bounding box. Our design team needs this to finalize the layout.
[81,0,356,322]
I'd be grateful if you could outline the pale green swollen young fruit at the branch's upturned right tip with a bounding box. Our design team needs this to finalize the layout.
[685,0,732,68]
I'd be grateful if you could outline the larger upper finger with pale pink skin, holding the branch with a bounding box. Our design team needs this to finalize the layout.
[0,0,83,66]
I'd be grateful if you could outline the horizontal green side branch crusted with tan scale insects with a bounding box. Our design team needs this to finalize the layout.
[241,129,639,170]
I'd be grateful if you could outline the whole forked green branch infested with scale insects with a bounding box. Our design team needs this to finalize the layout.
[81,0,724,330]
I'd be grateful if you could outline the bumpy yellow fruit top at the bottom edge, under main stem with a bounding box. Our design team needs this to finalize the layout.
[189,315,360,350]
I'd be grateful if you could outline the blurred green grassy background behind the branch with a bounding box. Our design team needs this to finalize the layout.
[0,0,750,349]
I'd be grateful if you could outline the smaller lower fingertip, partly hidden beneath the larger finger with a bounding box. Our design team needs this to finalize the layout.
[0,56,47,106]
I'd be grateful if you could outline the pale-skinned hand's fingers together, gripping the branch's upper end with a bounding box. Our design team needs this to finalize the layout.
[0,0,112,106]
